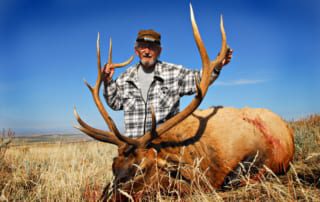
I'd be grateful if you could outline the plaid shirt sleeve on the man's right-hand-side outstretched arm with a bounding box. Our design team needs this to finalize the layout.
[178,68,220,96]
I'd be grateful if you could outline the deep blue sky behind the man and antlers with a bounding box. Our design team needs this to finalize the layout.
[0,0,320,133]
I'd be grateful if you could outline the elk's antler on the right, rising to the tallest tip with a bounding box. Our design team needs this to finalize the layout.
[126,4,228,147]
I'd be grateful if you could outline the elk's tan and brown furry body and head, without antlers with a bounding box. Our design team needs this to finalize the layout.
[105,107,294,199]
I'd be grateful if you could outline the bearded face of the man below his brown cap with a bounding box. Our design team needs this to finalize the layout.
[135,42,161,68]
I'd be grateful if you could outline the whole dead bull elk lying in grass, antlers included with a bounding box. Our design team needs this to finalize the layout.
[74,5,294,200]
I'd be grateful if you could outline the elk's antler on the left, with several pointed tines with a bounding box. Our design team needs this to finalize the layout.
[74,33,133,146]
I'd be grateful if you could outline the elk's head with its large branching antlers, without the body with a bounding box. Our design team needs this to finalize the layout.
[74,5,228,197]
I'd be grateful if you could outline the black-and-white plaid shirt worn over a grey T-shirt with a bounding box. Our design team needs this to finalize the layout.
[104,61,218,137]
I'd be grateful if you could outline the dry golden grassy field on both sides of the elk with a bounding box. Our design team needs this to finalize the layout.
[0,116,320,201]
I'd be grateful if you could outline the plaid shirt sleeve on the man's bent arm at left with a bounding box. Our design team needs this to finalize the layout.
[103,80,123,110]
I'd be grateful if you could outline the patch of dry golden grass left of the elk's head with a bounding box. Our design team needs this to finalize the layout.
[1,142,116,201]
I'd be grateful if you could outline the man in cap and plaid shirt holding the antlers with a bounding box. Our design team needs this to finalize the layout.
[103,30,232,137]
